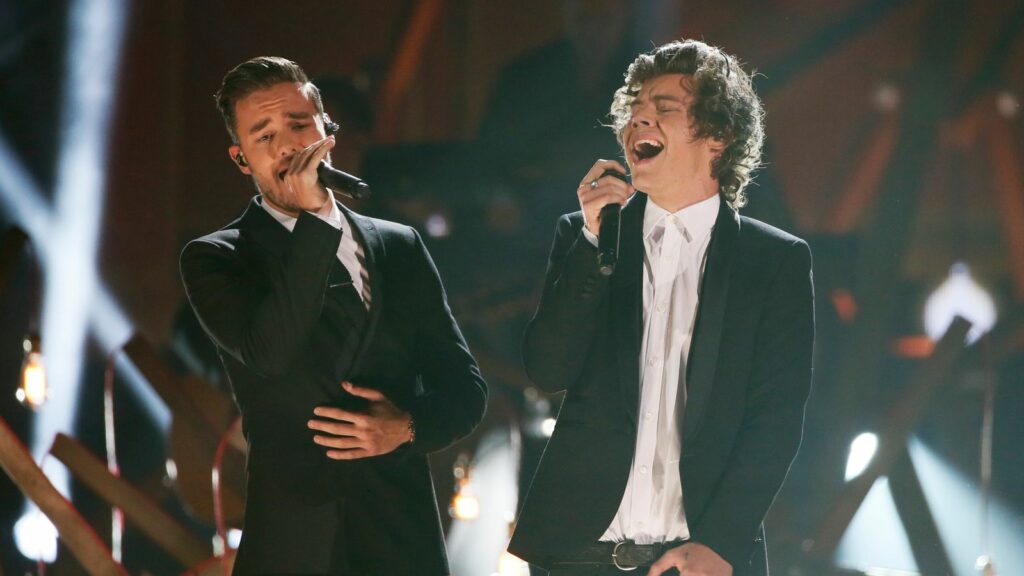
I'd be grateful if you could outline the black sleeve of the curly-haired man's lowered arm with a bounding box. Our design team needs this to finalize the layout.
[690,241,814,569]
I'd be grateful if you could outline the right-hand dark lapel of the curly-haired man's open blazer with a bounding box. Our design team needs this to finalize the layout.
[682,199,739,445]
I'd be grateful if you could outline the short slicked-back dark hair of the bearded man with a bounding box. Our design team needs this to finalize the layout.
[213,56,324,143]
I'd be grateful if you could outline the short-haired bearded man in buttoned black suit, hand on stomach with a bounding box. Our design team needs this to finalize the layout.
[181,57,486,576]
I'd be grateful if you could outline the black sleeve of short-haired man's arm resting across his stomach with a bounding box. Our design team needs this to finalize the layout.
[407,229,487,453]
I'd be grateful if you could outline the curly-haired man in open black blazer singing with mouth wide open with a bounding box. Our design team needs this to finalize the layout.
[509,40,814,576]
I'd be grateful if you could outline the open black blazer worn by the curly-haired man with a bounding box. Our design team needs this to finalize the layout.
[509,193,814,576]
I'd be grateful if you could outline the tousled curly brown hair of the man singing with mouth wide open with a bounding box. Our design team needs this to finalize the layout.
[610,40,764,208]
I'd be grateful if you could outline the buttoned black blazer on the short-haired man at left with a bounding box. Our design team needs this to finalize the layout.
[181,198,486,576]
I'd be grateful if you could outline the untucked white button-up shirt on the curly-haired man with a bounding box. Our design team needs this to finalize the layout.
[601,195,721,544]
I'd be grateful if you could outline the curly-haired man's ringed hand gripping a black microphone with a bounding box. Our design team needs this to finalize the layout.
[577,160,635,276]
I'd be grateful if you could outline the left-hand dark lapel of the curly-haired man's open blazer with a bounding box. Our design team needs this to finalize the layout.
[609,193,647,424]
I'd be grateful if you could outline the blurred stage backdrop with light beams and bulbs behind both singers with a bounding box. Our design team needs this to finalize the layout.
[0,0,1024,576]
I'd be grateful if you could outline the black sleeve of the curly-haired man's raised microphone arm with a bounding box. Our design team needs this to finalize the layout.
[523,213,608,393]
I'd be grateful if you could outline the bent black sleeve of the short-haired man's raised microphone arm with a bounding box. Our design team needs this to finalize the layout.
[181,212,341,377]
